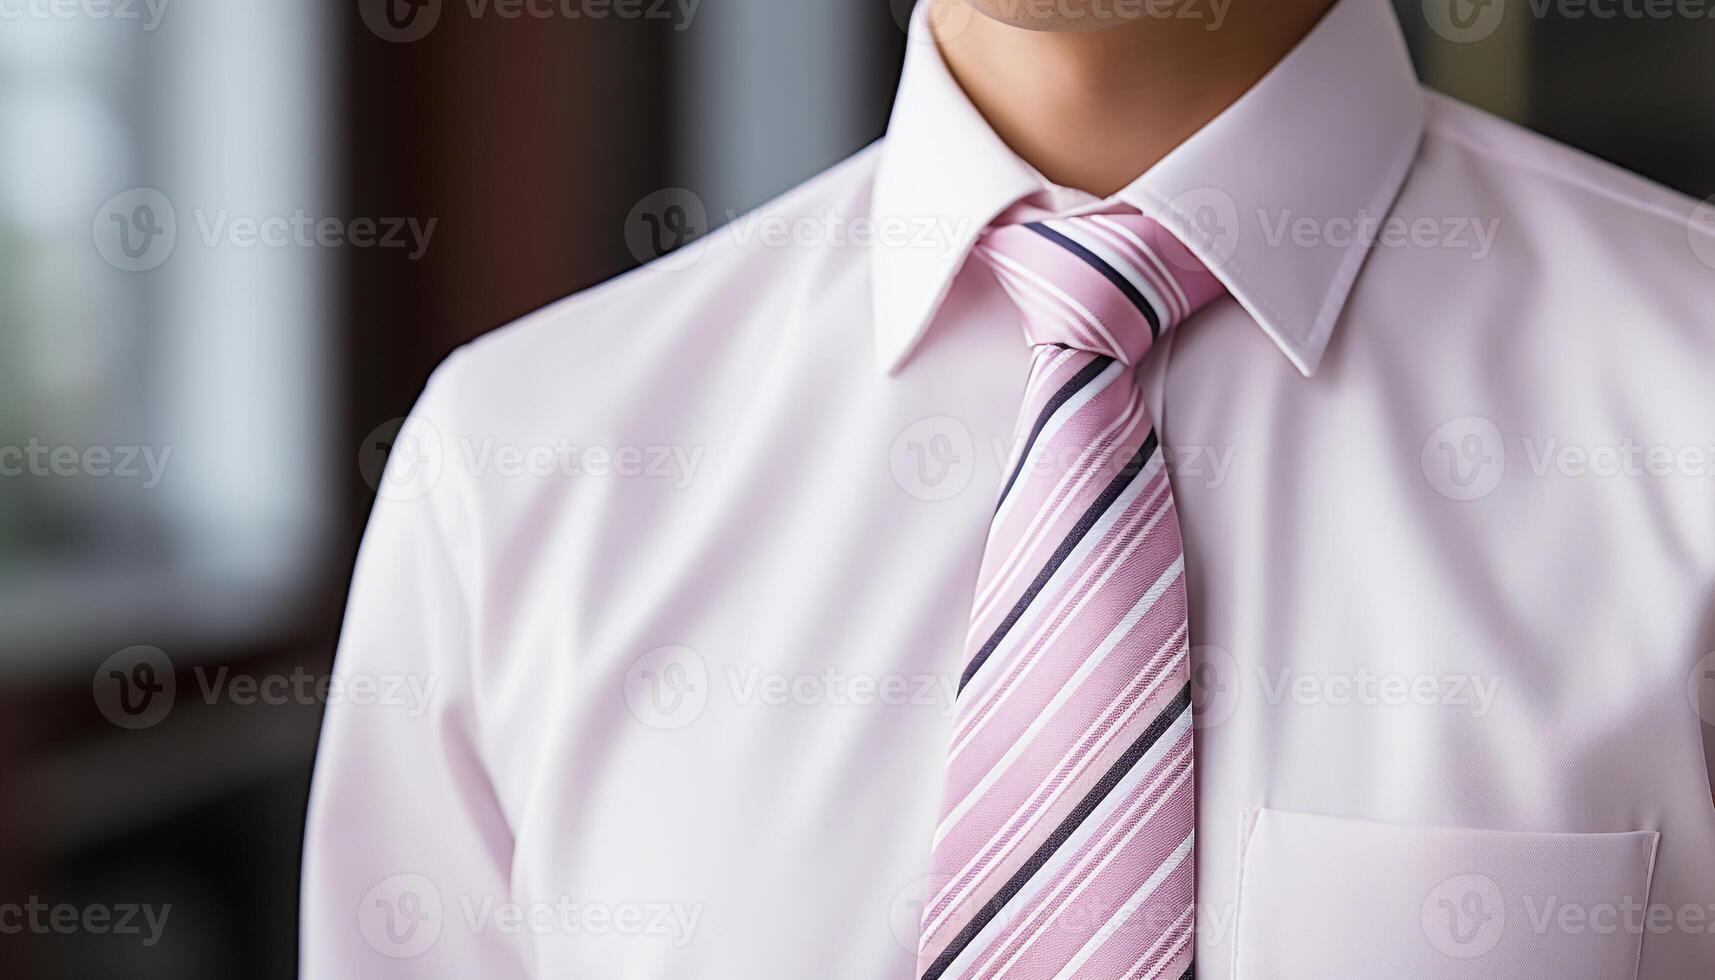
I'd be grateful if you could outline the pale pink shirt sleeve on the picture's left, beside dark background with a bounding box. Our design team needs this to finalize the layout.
[300,362,528,980]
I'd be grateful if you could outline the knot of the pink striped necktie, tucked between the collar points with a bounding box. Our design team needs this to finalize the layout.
[976,215,1226,364]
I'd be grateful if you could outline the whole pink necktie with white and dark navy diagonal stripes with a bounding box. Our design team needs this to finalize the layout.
[918,215,1223,980]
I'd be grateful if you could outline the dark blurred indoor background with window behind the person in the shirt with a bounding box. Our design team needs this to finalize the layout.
[0,0,1715,980]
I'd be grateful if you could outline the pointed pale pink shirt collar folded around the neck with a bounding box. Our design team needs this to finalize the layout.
[873,0,1423,376]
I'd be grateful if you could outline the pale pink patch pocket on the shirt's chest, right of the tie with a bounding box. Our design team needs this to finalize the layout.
[1233,808,1658,980]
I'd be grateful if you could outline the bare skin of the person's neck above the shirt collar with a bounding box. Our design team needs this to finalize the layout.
[926,0,1333,197]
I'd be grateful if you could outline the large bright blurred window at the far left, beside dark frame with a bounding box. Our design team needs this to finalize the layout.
[0,0,336,656]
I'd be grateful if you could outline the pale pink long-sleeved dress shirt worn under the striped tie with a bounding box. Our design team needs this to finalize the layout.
[304,0,1715,980]
